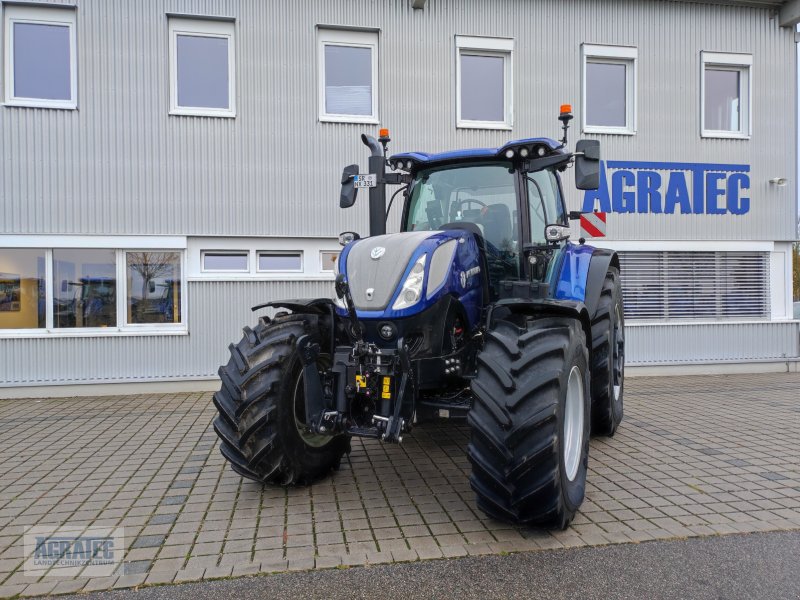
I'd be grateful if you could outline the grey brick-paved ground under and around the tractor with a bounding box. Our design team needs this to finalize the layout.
[0,374,800,597]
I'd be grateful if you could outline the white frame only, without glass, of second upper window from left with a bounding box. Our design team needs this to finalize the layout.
[167,15,236,119]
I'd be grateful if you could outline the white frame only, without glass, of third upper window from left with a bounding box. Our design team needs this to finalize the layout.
[317,26,380,125]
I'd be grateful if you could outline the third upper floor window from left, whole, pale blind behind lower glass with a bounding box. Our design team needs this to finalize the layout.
[318,29,378,123]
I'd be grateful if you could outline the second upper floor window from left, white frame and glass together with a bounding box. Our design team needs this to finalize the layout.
[169,18,236,117]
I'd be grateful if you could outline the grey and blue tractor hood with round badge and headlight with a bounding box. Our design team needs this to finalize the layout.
[339,230,482,318]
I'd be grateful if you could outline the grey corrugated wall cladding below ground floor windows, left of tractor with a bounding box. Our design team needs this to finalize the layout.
[0,282,333,387]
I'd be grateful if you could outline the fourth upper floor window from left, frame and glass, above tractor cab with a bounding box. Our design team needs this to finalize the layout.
[456,35,514,129]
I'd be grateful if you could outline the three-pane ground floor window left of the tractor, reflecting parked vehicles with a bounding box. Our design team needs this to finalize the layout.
[0,248,184,335]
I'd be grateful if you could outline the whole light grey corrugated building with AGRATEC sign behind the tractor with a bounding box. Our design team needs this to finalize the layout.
[0,0,800,395]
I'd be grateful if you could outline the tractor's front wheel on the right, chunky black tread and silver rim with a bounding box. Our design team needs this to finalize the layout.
[468,315,590,529]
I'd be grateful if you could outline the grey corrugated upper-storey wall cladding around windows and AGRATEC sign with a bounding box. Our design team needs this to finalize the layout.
[0,0,796,243]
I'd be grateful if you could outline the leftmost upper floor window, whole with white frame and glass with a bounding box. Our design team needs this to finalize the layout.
[4,6,78,108]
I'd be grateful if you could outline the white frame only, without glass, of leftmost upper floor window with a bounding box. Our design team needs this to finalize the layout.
[2,4,78,110]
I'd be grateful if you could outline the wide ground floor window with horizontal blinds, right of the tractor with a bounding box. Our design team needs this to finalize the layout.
[619,251,770,321]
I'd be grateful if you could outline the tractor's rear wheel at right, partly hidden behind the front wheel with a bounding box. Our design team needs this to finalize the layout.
[592,267,625,436]
